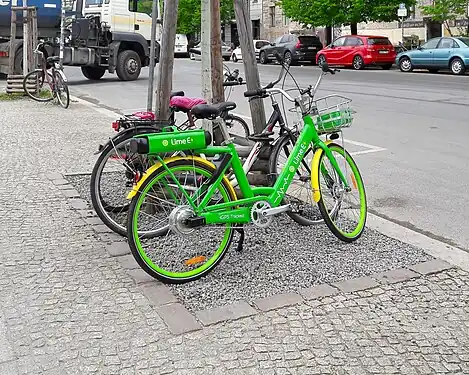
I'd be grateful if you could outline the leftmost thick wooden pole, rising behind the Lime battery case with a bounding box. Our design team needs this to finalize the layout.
[155,0,179,120]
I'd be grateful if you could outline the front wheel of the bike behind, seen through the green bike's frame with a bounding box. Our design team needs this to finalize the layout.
[269,133,324,226]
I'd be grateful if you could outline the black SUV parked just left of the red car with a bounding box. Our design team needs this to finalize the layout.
[259,34,323,64]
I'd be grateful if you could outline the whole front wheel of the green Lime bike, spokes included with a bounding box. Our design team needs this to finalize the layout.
[317,143,367,242]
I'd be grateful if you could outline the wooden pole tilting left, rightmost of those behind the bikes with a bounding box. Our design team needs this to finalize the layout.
[234,0,266,133]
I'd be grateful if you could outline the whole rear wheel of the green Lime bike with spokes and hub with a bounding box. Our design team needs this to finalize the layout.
[127,157,236,284]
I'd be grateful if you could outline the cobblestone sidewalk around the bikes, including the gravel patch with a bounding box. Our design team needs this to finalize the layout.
[0,97,469,375]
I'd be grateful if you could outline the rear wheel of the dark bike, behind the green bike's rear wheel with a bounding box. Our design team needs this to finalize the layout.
[90,128,154,236]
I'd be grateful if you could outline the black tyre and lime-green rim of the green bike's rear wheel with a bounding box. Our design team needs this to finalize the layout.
[127,157,236,284]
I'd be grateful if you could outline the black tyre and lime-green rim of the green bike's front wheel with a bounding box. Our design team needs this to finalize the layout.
[316,143,367,243]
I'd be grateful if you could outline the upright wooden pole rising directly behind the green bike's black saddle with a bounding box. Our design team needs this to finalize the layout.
[210,0,225,103]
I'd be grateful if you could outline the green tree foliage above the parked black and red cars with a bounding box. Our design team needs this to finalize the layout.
[280,0,416,27]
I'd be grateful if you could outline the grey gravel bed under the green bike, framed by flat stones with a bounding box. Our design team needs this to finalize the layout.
[67,176,432,312]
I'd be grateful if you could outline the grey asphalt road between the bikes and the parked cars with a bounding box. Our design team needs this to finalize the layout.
[66,59,469,250]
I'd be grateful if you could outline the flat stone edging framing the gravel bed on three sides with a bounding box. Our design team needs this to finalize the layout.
[46,173,469,335]
